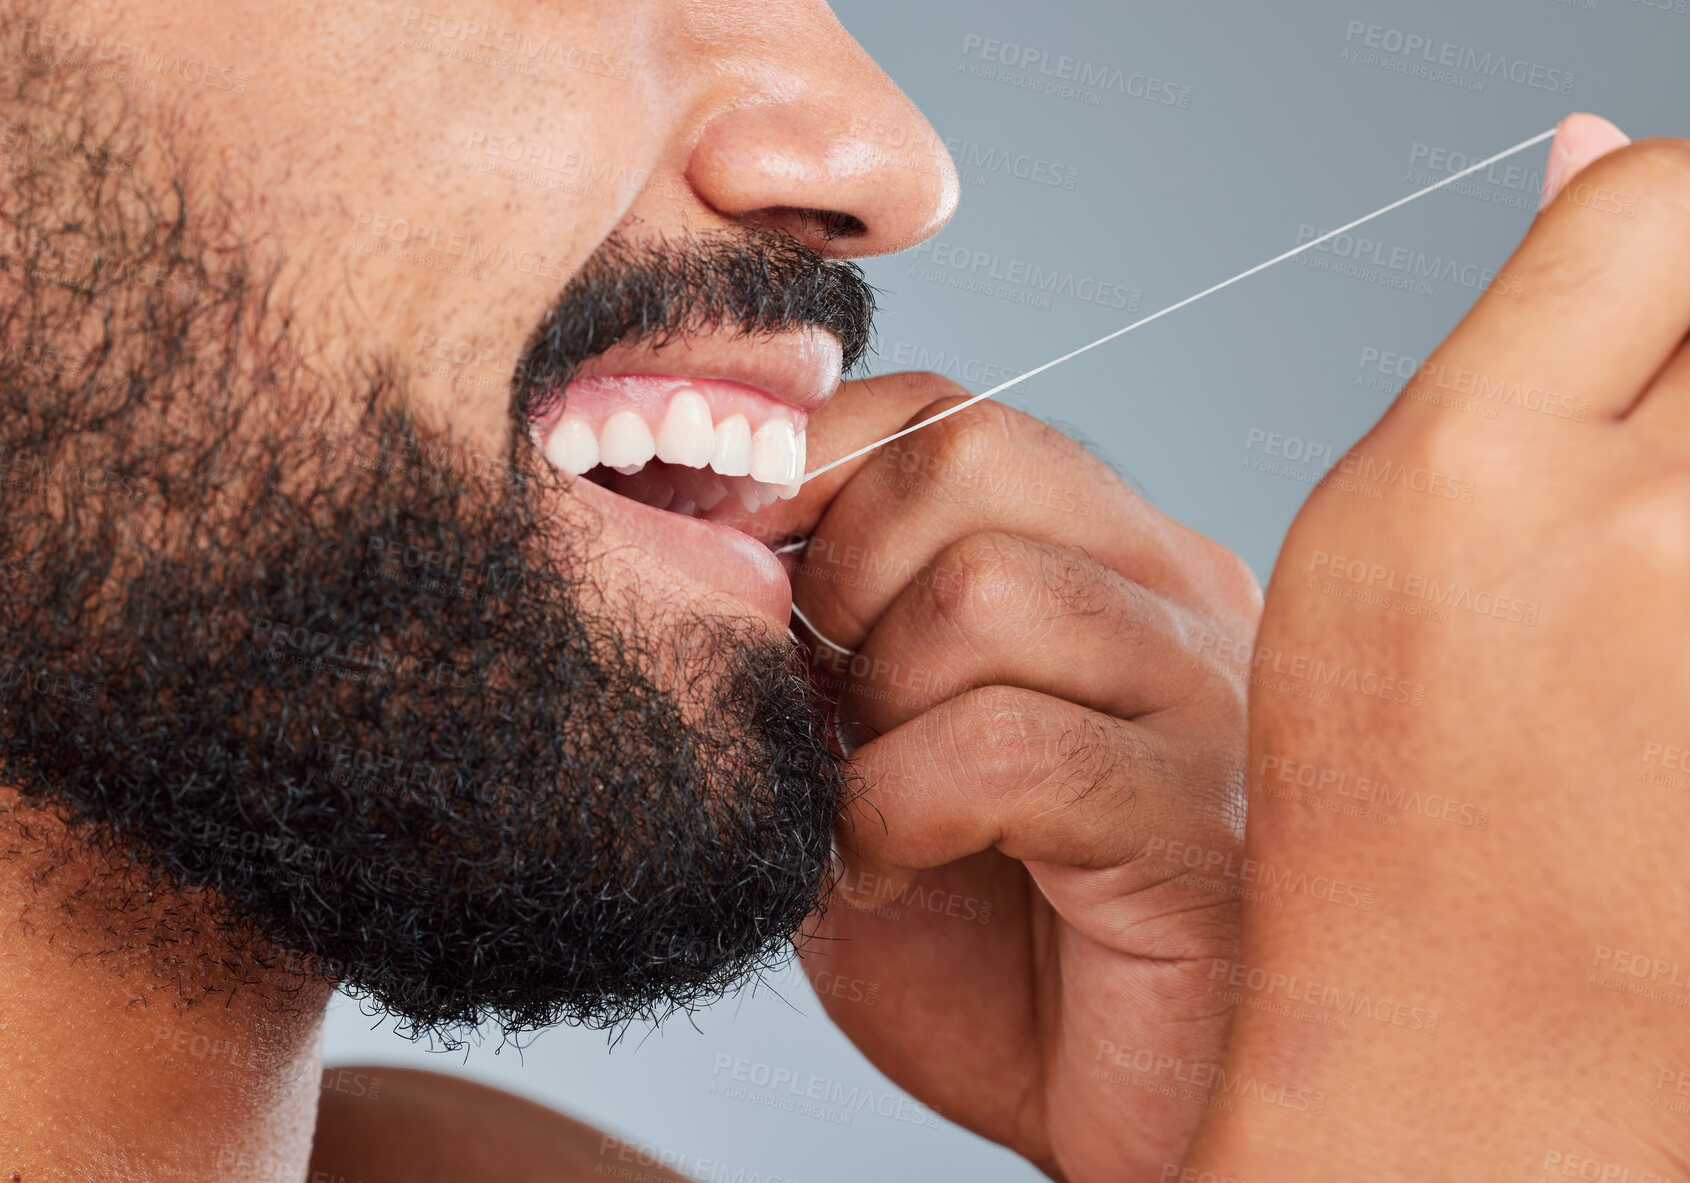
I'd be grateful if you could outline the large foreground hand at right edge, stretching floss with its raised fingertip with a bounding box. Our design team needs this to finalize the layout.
[1173,125,1690,1183]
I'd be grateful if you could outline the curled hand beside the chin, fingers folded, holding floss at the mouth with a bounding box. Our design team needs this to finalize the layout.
[733,375,1261,1183]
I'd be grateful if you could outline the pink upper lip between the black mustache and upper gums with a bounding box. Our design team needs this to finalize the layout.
[571,326,843,412]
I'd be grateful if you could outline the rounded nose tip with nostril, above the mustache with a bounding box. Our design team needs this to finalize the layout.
[686,59,960,257]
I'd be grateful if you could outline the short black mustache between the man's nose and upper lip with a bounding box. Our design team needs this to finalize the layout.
[512,228,875,423]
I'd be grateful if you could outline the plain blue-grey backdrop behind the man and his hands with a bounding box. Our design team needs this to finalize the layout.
[328,0,1690,1183]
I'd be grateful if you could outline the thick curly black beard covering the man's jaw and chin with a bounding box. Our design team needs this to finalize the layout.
[0,16,848,1046]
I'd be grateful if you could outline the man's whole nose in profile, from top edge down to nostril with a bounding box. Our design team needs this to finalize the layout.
[686,0,958,257]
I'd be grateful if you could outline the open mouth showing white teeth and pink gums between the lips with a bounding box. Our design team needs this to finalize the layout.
[529,373,810,517]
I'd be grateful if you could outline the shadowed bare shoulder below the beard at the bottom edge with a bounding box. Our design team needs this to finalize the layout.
[308,1066,688,1183]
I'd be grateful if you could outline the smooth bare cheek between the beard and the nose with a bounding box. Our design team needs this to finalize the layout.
[184,3,672,448]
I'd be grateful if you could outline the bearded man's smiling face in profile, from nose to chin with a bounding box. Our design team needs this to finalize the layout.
[0,0,957,1028]
